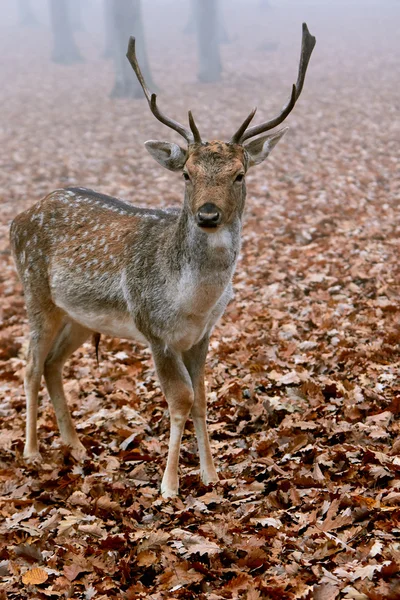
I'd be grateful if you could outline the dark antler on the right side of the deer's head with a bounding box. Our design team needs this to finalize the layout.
[231,23,316,144]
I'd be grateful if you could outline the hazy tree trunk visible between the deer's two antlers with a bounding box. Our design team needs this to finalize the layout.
[196,0,222,83]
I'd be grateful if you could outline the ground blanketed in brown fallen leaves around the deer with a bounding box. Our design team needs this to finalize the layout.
[0,2,400,600]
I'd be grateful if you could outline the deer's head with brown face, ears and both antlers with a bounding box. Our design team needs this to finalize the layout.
[127,23,315,233]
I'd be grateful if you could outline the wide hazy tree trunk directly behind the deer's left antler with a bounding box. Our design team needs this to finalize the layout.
[111,0,156,98]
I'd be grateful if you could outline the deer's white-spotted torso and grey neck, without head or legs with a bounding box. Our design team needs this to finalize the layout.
[12,188,240,352]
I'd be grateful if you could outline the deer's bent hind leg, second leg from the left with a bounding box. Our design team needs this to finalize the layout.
[44,321,92,458]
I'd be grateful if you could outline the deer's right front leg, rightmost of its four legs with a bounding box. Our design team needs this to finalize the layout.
[183,336,219,485]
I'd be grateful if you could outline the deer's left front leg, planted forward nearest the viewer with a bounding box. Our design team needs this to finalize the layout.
[152,345,194,498]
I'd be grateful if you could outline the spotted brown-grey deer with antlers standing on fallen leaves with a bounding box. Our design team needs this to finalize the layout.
[10,23,316,498]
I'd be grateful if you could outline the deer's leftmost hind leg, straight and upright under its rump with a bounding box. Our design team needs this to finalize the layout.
[24,306,63,460]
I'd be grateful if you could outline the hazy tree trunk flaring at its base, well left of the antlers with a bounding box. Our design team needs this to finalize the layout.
[50,0,82,65]
